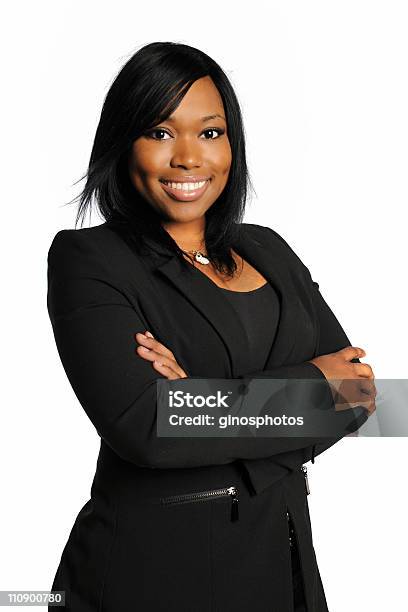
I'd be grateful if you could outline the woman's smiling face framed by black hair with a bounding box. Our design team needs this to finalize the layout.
[129,77,232,223]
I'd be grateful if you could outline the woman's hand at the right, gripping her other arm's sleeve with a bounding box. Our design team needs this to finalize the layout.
[309,346,377,414]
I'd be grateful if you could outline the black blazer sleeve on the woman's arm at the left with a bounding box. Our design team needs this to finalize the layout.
[47,230,364,468]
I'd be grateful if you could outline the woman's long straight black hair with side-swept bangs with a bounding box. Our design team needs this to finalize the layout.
[69,42,252,275]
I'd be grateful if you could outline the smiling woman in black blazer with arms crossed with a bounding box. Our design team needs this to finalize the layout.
[48,42,373,612]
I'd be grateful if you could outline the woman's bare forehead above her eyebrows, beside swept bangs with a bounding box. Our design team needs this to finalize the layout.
[167,77,225,123]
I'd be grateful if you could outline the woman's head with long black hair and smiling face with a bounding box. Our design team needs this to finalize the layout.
[70,43,251,285]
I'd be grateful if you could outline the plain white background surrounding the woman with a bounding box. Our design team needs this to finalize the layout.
[0,0,408,612]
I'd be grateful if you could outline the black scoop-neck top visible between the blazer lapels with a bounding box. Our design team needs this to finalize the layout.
[219,282,279,372]
